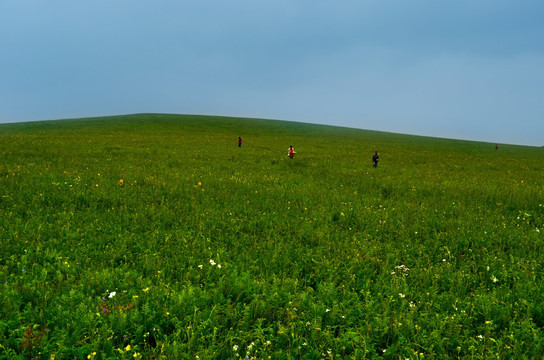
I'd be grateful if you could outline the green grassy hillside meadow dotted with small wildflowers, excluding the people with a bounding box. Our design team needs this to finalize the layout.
[0,114,544,360]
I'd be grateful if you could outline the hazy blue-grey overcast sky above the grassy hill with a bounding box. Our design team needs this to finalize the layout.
[0,0,544,146]
